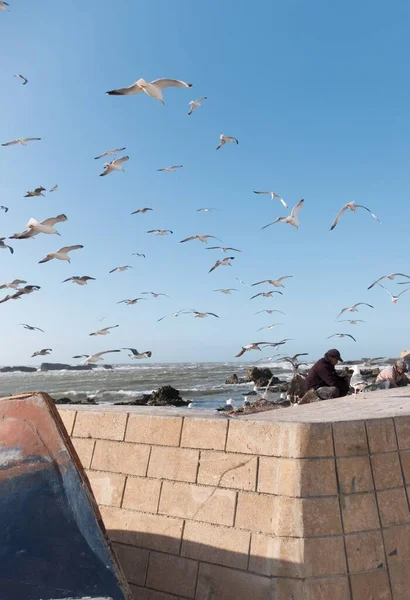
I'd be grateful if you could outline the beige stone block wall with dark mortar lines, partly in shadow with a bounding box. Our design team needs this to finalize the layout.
[60,407,410,600]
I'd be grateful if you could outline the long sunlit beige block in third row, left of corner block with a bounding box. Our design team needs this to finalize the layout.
[158,481,236,526]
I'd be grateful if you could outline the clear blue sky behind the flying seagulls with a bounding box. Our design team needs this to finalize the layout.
[0,0,410,364]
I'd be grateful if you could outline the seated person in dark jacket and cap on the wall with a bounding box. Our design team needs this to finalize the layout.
[306,348,350,400]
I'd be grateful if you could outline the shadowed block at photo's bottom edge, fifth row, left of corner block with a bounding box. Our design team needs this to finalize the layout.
[195,563,272,600]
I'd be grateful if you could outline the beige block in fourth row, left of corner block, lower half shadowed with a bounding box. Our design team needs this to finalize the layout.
[181,521,250,571]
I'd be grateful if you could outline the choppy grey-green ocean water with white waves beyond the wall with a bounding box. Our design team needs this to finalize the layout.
[0,362,298,408]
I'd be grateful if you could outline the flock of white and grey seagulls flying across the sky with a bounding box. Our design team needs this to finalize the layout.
[0,0,410,368]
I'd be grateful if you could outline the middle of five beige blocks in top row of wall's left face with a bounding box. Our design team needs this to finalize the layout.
[125,415,182,446]
